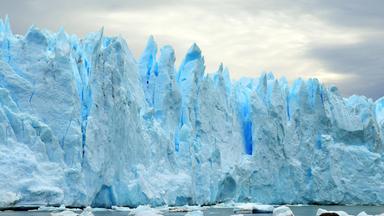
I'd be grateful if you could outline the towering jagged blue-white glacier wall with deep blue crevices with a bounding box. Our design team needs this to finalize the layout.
[0,16,384,207]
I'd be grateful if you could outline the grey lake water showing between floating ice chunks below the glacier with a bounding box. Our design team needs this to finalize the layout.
[0,206,384,216]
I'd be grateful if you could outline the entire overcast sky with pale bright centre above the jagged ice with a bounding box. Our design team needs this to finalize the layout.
[0,0,384,100]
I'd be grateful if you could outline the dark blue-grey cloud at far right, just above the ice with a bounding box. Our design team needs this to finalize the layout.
[309,38,384,99]
